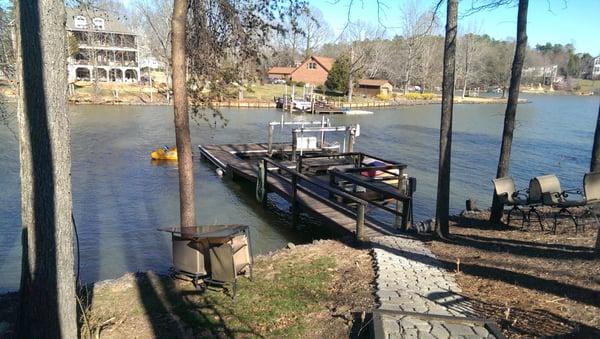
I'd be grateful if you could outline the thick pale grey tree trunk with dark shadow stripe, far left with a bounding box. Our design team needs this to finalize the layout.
[15,0,77,338]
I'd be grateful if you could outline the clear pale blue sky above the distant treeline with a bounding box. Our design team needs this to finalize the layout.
[309,0,600,56]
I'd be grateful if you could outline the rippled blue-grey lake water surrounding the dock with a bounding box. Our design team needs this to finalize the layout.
[0,96,600,291]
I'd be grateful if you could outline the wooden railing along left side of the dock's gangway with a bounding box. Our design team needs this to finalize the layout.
[262,158,368,241]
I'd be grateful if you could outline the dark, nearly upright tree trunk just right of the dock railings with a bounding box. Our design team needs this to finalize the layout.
[436,0,458,238]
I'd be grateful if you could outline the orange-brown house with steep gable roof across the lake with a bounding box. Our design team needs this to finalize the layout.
[268,56,335,86]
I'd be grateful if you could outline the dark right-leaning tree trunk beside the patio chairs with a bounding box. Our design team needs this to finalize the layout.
[490,0,529,222]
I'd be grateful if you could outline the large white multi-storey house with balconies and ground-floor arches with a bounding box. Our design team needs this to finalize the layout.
[67,8,140,83]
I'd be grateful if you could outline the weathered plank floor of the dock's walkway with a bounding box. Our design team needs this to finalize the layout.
[199,143,397,240]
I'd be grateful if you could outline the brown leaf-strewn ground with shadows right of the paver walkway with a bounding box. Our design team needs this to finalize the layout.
[429,212,600,338]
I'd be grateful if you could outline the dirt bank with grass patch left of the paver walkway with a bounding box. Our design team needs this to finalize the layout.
[0,240,375,338]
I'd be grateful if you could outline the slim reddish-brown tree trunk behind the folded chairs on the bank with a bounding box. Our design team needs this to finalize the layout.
[171,0,196,232]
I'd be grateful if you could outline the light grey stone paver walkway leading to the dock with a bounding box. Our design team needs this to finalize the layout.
[371,236,502,339]
